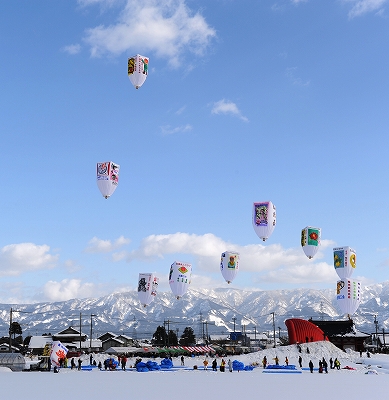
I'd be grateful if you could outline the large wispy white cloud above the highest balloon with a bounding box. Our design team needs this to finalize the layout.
[82,0,216,67]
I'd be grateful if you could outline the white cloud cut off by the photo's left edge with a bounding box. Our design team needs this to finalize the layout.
[0,243,58,276]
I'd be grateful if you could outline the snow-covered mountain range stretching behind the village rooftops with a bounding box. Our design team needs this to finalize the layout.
[0,282,389,339]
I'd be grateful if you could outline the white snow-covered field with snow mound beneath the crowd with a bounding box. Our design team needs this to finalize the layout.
[0,342,389,400]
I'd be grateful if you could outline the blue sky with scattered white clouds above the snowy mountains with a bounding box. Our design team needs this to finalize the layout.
[0,0,389,302]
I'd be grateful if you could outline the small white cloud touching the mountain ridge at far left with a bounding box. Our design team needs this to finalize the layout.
[43,279,95,301]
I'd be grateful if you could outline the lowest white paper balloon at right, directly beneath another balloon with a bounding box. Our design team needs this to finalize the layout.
[336,278,361,315]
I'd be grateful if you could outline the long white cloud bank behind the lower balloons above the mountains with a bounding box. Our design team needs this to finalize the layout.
[123,232,336,284]
